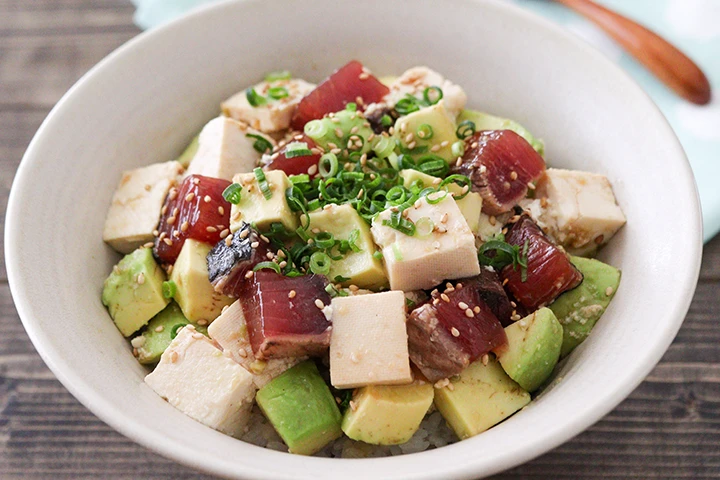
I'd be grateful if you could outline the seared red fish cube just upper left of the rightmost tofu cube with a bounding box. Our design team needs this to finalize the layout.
[451,130,545,215]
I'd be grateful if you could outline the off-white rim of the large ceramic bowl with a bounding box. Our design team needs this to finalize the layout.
[5,0,702,480]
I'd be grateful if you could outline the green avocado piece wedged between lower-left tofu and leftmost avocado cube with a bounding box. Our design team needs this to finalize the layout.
[133,302,207,364]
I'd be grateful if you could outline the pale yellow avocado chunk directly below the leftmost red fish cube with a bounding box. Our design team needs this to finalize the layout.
[170,238,233,323]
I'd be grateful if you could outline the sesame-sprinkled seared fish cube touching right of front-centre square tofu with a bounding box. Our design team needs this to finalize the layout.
[407,282,507,382]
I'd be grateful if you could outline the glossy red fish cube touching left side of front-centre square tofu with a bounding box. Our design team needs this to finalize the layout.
[240,270,332,360]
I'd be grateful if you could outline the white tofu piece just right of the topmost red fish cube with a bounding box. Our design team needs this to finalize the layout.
[383,67,467,117]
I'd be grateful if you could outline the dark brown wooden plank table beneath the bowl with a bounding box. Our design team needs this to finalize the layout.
[0,0,720,479]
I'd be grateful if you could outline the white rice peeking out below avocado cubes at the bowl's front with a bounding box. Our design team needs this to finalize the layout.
[241,406,458,458]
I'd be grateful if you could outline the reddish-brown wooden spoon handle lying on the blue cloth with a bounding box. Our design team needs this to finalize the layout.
[555,0,712,105]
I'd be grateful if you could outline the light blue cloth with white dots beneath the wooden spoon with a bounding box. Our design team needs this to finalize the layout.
[133,0,720,241]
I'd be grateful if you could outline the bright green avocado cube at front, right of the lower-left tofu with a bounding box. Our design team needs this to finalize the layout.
[256,360,342,455]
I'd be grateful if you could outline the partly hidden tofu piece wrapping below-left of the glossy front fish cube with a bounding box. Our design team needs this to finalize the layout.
[208,300,305,389]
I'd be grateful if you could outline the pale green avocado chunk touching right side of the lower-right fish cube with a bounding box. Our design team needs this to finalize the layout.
[498,308,563,392]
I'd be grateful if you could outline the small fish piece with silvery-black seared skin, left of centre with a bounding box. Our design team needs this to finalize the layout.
[207,222,270,297]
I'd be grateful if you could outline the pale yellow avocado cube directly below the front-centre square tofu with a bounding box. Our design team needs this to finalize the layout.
[342,382,434,445]
